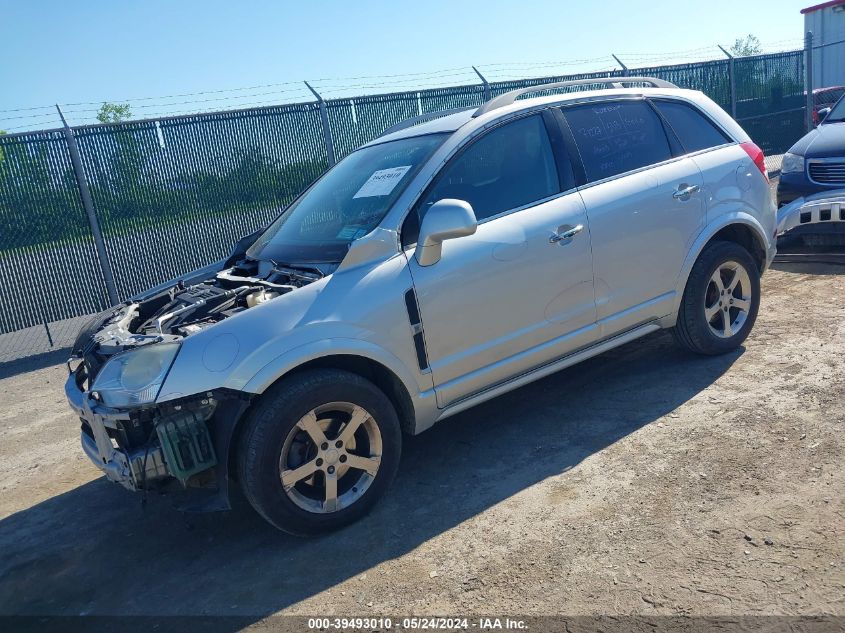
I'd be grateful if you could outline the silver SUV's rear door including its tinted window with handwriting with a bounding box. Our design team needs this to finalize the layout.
[561,99,705,336]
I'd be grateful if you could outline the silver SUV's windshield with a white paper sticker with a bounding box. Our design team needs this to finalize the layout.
[247,134,448,264]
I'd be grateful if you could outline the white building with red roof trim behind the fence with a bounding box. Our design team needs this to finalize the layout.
[801,0,845,89]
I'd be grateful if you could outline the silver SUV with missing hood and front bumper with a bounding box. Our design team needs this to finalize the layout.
[66,77,775,534]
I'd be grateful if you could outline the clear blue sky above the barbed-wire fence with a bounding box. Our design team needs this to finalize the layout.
[0,0,813,131]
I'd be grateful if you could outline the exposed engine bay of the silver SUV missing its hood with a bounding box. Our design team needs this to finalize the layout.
[73,259,332,378]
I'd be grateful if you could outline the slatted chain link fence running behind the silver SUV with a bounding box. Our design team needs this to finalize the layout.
[0,51,806,365]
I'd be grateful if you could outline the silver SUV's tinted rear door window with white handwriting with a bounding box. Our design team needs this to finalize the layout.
[563,101,672,182]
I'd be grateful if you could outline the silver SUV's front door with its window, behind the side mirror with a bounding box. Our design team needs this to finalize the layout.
[407,114,596,407]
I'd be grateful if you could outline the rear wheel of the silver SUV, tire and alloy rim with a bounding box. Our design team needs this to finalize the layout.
[673,242,760,356]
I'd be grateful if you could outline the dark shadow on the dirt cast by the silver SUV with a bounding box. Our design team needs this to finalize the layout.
[0,333,743,630]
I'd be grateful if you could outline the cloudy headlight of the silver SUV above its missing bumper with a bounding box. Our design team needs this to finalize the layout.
[91,343,179,407]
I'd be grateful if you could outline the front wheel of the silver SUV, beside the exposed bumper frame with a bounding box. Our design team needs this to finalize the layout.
[237,369,402,536]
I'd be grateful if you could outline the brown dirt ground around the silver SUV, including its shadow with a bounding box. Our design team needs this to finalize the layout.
[0,266,845,621]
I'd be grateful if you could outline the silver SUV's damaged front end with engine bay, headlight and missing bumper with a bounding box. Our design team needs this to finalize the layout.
[65,260,325,509]
